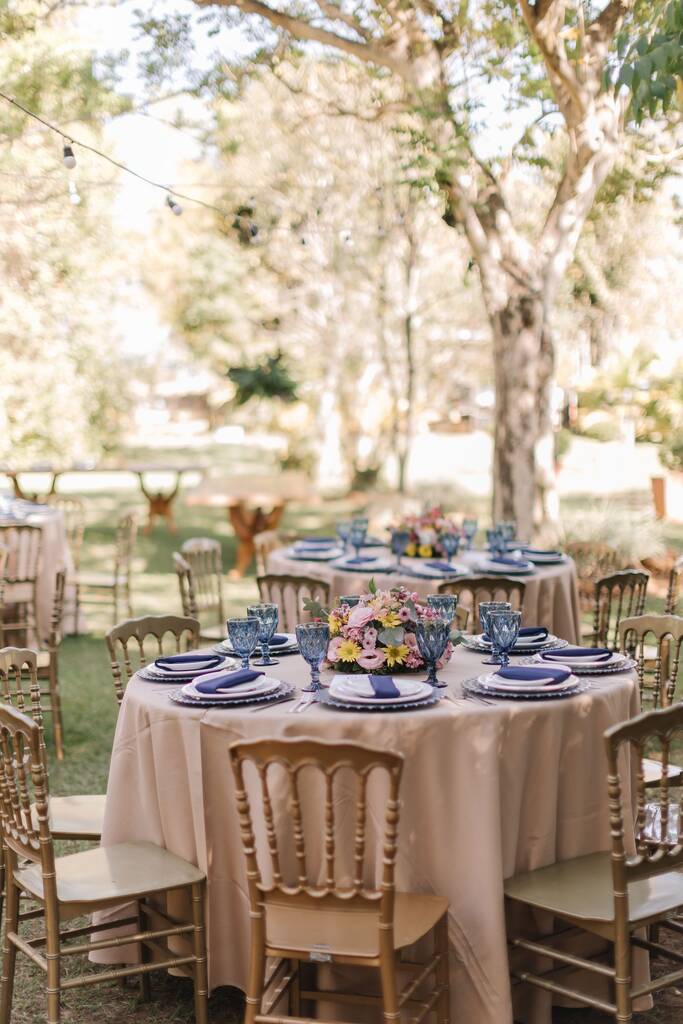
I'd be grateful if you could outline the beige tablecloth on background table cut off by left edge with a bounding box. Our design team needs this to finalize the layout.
[0,509,74,645]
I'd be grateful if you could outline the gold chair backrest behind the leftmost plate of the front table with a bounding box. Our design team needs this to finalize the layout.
[104,615,200,707]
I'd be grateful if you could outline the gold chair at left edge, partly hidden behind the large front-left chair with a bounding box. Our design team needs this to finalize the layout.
[0,647,104,842]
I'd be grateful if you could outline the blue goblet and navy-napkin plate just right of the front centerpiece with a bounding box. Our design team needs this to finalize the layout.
[463,608,591,703]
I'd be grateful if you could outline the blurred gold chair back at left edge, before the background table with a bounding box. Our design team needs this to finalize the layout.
[0,524,43,644]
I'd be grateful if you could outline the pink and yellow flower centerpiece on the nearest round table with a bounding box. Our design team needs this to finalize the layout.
[311,581,458,675]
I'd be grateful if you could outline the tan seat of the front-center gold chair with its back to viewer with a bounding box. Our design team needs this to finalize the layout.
[265,893,449,956]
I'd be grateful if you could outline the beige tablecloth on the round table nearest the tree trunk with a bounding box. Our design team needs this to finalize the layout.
[266,548,581,643]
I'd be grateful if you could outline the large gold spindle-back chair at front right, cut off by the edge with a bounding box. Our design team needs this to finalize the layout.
[505,705,683,1024]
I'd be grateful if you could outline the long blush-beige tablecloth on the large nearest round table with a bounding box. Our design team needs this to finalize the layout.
[100,647,638,1024]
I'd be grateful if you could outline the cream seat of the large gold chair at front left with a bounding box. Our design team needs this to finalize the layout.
[14,843,205,903]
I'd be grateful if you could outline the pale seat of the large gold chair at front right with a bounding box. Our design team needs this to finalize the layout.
[505,853,683,922]
